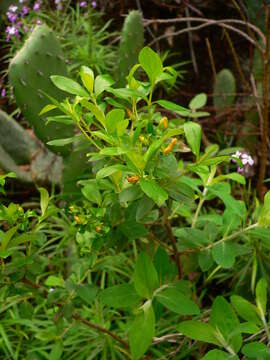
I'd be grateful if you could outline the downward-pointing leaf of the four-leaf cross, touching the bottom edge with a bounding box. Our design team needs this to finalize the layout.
[129,306,155,360]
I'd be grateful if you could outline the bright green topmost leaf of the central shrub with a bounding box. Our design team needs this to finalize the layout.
[139,46,163,84]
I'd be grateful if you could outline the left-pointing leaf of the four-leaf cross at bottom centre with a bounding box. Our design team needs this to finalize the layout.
[100,284,140,309]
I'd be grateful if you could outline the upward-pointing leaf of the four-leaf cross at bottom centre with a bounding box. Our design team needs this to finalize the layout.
[134,252,159,299]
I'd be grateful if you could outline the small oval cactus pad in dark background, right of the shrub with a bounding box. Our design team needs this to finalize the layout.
[213,69,236,110]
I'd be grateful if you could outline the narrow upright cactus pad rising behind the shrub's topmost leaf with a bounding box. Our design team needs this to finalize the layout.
[118,10,144,86]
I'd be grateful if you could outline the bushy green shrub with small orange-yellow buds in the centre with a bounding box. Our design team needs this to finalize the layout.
[39,47,270,359]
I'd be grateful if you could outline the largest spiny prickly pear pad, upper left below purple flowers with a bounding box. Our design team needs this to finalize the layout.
[9,25,73,155]
